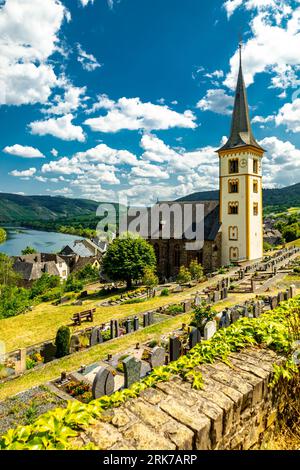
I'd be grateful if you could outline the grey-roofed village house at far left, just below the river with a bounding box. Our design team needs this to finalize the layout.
[13,253,69,287]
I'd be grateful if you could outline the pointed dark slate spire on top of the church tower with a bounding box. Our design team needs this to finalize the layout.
[220,41,263,150]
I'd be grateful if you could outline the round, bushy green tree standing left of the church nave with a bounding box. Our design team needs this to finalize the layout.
[102,234,156,288]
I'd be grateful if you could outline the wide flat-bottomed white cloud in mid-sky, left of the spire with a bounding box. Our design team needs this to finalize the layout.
[84,96,197,132]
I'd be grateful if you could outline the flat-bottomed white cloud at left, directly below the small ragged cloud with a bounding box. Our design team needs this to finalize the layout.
[29,114,85,142]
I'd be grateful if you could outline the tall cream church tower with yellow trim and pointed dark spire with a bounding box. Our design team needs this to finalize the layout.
[218,45,264,265]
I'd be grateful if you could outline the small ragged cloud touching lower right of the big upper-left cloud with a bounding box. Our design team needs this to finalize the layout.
[43,83,86,115]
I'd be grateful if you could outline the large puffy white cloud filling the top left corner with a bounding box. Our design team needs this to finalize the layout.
[0,0,70,105]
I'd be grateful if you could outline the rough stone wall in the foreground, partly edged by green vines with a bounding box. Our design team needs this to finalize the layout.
[77,348,282,450]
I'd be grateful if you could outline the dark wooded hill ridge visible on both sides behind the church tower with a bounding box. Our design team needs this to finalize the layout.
[178,183,300,208]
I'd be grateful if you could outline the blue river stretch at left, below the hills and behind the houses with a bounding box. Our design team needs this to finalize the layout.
[0,227,82,256]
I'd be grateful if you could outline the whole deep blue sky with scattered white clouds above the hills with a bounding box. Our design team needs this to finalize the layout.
[0,0,300,203]
